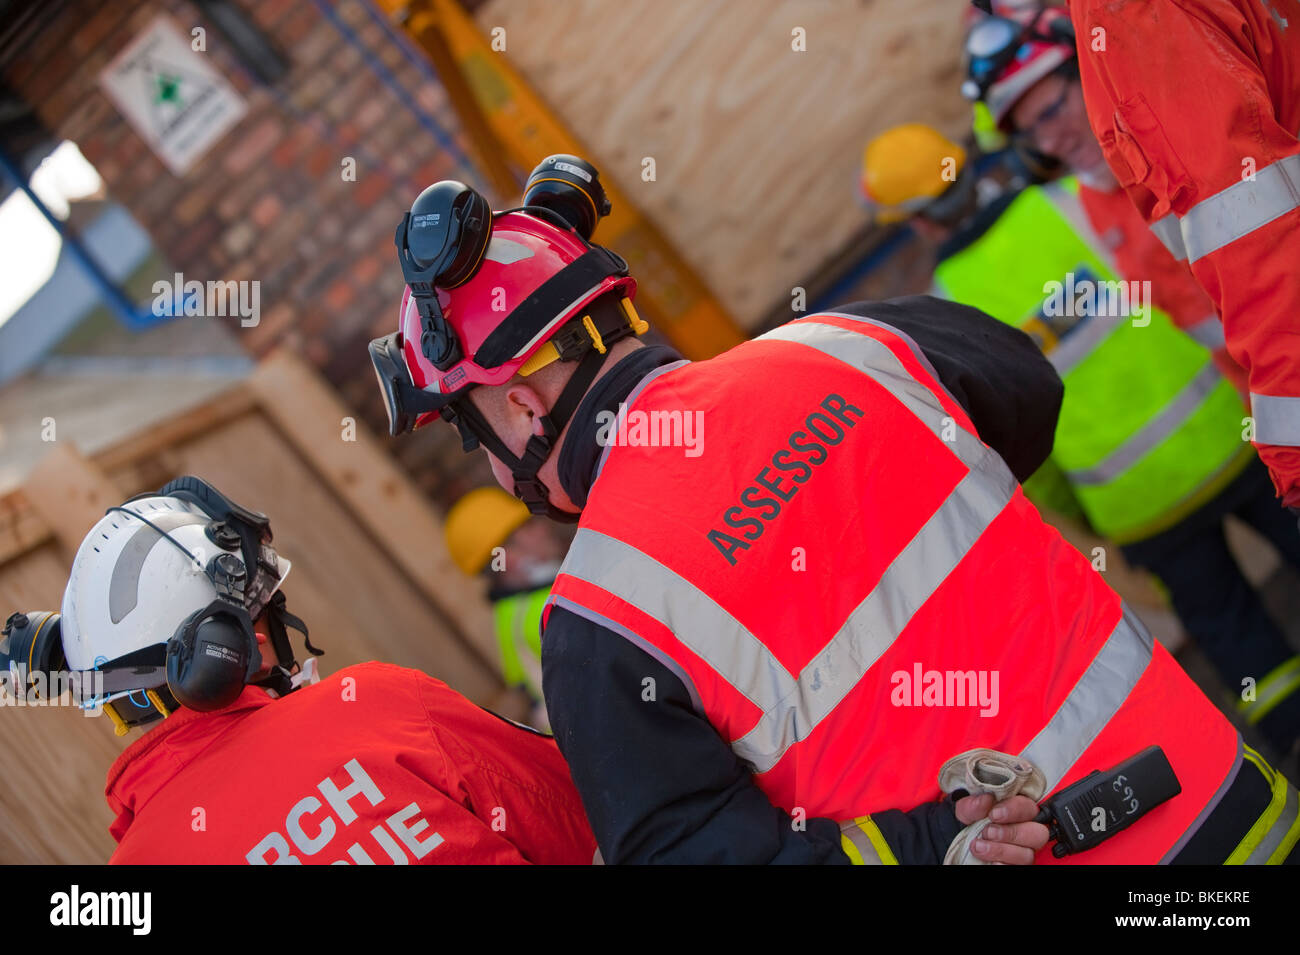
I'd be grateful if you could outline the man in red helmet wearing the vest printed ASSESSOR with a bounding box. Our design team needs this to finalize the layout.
[371,156,1300,864]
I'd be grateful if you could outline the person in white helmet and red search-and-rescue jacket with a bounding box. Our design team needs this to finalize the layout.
[0,477,595,864]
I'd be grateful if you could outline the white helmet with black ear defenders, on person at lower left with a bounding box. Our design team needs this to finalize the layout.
[7,477,320,733]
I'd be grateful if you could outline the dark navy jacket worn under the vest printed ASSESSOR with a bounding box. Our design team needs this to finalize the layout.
[542,296,1062,864]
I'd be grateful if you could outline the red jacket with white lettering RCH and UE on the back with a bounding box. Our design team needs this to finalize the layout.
[105,663,595,864]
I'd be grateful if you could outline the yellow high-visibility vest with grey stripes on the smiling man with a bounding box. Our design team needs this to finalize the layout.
[935,174,1253,543]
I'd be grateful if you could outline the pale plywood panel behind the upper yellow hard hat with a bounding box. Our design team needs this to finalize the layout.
[476,0,970,327]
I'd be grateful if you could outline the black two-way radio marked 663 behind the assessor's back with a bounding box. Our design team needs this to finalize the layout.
[1035,746,1183,859]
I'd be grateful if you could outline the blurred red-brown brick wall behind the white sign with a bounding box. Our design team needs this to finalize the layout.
[4,0,498,505]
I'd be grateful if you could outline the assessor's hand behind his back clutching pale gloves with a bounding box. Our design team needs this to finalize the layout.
[939,750,1048,865]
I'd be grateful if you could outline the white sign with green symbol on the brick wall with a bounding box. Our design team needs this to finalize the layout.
[99,17,248,175]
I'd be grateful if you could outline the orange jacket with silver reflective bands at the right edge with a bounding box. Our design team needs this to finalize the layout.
[1070,0,1300,507]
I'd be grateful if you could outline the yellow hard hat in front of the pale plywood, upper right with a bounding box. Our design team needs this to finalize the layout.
[861,122,966,222]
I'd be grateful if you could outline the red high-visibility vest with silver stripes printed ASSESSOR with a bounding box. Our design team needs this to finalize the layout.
[551,313,1239,863]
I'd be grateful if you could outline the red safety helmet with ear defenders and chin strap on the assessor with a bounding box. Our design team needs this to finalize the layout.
[371,156,649,520]
